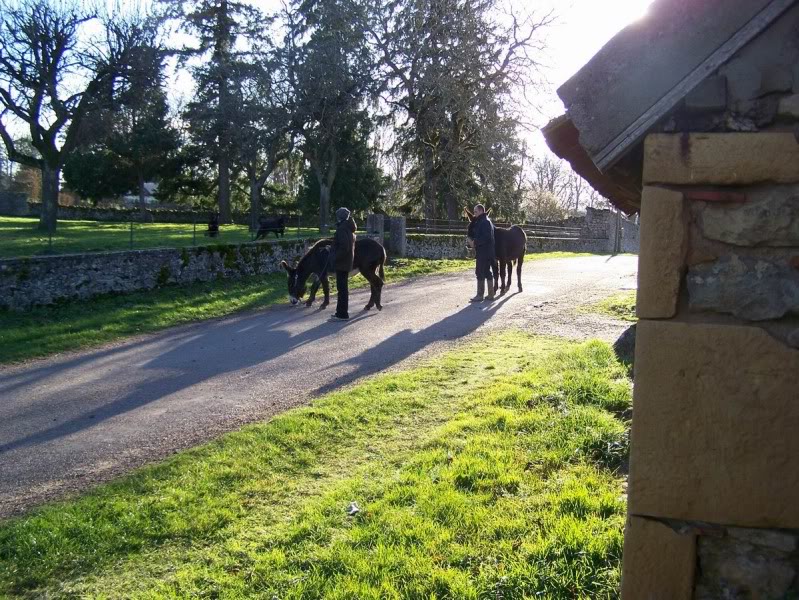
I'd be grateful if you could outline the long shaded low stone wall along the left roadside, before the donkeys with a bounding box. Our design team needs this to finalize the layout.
[0,240,312,310]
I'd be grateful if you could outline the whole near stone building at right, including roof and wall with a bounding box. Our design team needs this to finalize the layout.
[545,0,799,600]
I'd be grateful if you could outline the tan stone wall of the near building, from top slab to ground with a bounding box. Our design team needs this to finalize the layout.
[622,133,799,600]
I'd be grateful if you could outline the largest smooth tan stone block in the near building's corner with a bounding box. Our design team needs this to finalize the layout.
[629,320,799,528]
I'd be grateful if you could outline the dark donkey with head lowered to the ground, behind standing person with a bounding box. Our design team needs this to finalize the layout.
[280,238,386,310]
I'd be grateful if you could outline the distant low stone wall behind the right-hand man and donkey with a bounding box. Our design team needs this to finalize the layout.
[405,234,616,259]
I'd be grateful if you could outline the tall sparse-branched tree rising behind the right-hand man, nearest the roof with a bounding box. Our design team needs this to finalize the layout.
[367,0,550,218]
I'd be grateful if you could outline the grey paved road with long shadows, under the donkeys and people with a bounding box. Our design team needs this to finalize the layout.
[0,256,637,517]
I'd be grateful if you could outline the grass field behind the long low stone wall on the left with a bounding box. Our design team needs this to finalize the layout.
[0,217,319,258]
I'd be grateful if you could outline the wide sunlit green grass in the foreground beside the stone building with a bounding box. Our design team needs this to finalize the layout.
[0,332,630,600]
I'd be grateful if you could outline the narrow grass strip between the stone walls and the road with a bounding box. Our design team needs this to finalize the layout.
[0,252,588,364]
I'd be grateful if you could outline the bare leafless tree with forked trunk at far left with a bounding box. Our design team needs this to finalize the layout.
[0,0,152,233]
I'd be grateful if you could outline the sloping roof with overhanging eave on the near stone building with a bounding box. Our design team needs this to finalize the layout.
[544,0,799,212]
